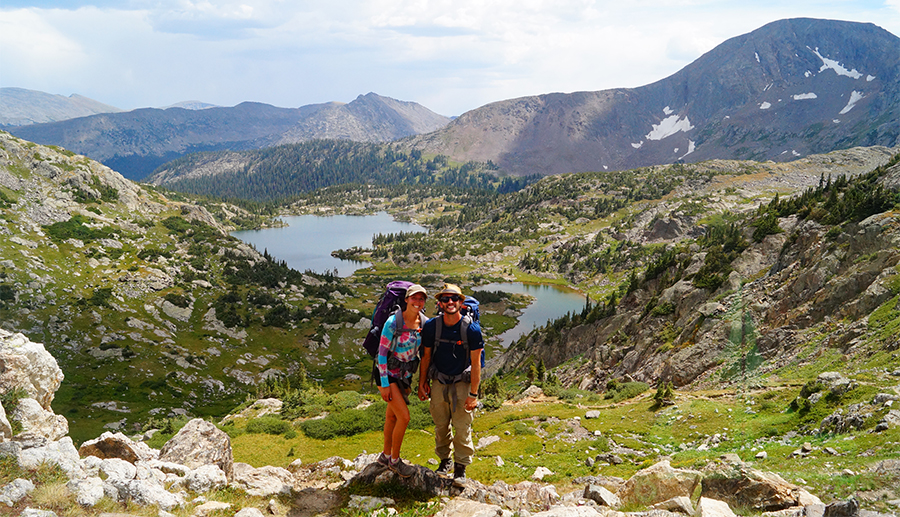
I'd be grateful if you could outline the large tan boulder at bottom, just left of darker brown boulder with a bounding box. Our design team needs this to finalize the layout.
[617,460,703,506]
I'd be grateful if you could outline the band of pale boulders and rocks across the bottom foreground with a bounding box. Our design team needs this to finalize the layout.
[0,331,898,517]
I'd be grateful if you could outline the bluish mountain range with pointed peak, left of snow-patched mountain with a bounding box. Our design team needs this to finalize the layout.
[7,93,450,180]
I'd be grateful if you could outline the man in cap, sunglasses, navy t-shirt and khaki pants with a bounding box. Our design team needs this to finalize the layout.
[419,284,484,487]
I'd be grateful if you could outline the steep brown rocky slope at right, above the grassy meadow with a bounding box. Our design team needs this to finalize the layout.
[496,173,900,392]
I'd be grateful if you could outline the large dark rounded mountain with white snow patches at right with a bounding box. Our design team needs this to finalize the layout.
[404,19,900,174]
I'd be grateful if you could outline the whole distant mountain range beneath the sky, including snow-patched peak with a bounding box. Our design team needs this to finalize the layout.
[9,18,900,179]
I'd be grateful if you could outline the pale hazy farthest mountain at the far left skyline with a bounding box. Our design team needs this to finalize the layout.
[0,88,122,126]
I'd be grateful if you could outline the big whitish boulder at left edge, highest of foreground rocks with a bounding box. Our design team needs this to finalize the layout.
[0,329,63,411]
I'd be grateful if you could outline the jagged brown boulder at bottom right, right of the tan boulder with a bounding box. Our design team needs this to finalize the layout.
[701,467,801,512]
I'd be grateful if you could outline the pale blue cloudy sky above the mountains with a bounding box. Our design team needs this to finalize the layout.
[0,0,900,116]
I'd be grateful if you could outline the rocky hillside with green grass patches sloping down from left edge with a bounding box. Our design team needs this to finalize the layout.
[0,132,340,438]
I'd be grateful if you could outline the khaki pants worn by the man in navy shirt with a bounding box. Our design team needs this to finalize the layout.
[429,381,475,465]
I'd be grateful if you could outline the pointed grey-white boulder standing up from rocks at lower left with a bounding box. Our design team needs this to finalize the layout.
[159,418,234,480]
